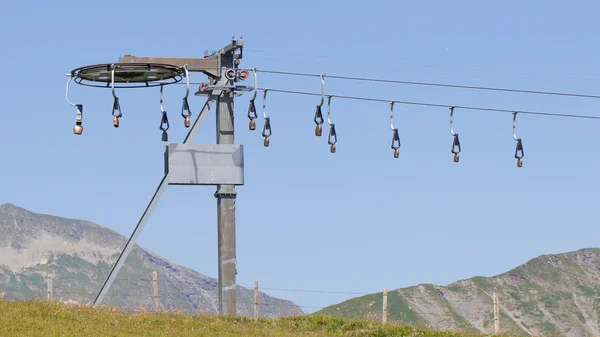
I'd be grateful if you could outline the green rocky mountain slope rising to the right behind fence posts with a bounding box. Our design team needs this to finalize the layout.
[319,249,600,337]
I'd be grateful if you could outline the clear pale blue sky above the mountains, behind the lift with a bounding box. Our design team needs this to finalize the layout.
[0,0,600,312]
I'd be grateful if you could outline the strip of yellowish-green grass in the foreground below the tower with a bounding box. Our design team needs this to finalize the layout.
[0,300,510,337]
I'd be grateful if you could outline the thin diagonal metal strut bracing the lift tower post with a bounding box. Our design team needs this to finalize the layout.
[92,77,227,307]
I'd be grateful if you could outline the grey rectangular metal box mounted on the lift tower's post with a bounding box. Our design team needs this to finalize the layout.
[165,144,244,185]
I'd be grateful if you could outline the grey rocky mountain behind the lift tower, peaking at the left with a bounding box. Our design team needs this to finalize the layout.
[0,204,302,317]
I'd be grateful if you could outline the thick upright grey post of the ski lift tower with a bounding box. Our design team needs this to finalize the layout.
[215,53,237,316]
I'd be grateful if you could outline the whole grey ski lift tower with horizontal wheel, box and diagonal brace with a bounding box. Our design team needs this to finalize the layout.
[66,38,253,316]
